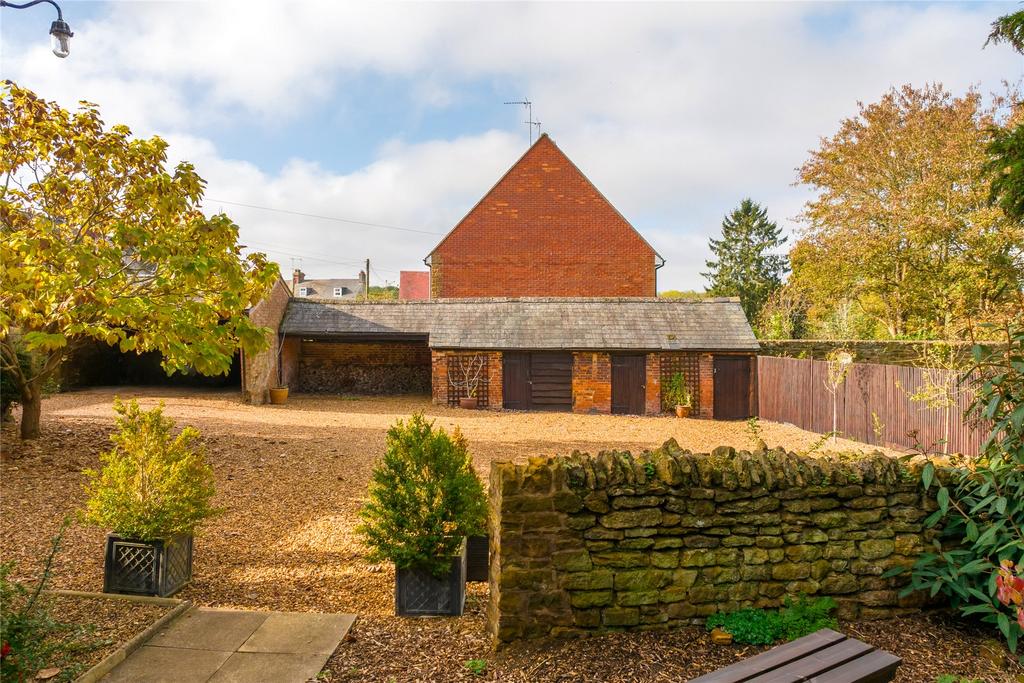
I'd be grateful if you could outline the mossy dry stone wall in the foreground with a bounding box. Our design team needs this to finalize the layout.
[487,441,935,646]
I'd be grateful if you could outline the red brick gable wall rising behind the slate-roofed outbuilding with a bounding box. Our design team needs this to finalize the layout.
[430,135,655,298]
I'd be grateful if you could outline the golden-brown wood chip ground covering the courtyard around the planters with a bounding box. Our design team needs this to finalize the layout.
[0,387,1015,681]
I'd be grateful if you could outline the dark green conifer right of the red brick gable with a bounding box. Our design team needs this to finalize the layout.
[701,199,786,322]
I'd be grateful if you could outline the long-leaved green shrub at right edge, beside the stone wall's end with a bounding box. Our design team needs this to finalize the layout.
[901,316,1024,659]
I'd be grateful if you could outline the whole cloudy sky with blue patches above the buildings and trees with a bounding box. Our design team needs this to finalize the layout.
[0,0,1024,289]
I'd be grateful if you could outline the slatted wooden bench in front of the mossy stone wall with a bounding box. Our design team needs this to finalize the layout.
[690,629,903,683]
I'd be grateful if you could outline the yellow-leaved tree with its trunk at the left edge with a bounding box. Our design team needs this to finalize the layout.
[0,82,278,438]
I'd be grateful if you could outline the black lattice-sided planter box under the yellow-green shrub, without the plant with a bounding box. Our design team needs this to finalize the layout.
[103,533,193,598]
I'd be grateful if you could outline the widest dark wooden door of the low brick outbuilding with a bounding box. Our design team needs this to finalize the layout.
[502,351,572,411]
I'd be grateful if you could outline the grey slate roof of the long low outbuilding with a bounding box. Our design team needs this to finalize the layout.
[281,298,759,351]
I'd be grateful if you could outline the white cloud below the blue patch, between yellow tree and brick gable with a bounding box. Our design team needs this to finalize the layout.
[168,131,521,282]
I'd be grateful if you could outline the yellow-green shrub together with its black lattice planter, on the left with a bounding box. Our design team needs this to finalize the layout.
[85,399,215,597]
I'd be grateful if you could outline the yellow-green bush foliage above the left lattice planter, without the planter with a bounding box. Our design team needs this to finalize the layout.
[85,399,215,541]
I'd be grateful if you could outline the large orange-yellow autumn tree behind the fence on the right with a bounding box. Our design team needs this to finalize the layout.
[791,85,1024,338]
